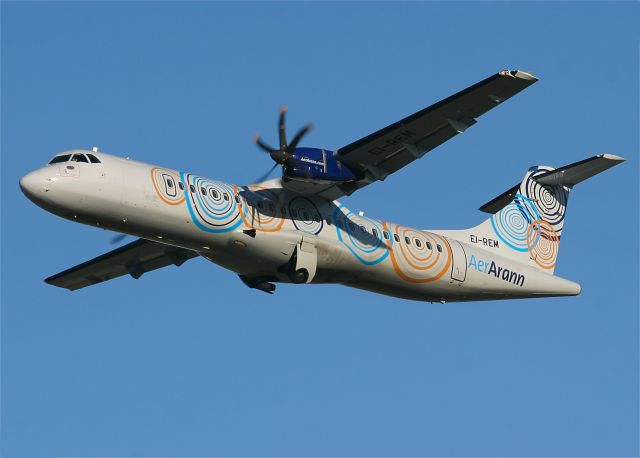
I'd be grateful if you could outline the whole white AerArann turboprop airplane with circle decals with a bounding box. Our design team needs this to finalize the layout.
[20,70,624,302]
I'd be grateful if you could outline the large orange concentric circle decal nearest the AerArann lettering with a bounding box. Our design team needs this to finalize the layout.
[383,223,452,283]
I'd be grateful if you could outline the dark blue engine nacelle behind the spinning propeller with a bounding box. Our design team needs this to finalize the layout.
[284,148,362,182]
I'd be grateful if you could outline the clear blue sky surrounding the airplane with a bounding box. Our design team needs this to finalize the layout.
[1,2,640,457]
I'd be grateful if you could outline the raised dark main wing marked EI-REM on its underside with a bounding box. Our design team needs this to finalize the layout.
[308,70,538,199]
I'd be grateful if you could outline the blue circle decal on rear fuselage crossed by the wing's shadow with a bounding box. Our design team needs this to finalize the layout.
[333,205,389,266]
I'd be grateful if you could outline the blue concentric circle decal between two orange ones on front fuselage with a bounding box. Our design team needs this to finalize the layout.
[182,173,242,233]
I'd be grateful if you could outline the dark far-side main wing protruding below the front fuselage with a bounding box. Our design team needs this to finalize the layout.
[45,239,198,291]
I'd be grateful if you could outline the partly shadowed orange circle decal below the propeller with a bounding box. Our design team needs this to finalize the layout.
[233,185,285,232]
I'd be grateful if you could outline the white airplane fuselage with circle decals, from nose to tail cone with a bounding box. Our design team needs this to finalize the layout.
[21,151,580,302]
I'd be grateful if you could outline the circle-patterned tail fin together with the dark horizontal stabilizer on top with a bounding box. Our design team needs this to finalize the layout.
[438,154,624,274]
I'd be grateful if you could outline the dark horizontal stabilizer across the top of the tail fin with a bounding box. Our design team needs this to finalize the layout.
[480,154,624,214]
